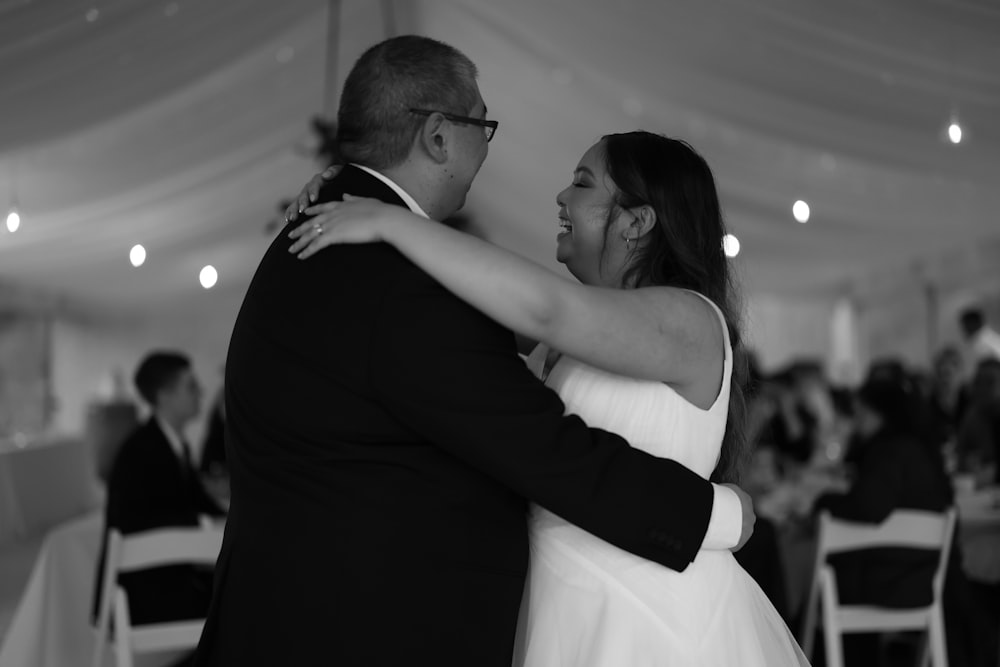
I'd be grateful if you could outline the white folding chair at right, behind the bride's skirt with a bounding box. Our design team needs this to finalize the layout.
[802,509,955,667]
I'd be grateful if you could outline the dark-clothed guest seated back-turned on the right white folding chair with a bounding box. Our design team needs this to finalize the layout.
[816,374,987,667]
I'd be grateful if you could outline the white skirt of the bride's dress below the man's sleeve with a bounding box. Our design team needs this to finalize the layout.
[514,507,809,667]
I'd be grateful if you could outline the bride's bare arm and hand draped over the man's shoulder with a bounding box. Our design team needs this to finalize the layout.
[290,199,723,384]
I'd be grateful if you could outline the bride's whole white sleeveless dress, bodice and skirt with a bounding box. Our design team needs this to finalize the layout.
[514,294,808,667]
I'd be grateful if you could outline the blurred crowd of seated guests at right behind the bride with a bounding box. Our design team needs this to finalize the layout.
[738,310,1000,667]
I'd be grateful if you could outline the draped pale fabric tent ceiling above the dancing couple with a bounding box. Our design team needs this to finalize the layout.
[0,0,1000,309]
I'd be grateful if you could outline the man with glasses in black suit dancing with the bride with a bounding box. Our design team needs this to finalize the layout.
[197,36,752,667]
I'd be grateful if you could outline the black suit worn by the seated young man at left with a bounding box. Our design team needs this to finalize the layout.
[93,418,223,625]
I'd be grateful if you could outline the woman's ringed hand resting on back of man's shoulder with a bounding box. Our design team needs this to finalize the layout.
[288,194,422,259]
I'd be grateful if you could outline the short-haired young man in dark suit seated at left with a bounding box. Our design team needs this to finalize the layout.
[94,352,223,656]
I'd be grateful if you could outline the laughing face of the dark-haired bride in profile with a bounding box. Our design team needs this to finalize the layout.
[556,143,629,287]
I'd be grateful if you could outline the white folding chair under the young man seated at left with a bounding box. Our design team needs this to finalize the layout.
[93,527,222,667]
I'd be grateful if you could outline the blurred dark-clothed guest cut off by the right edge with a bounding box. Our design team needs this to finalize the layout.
[956,359,1000,484]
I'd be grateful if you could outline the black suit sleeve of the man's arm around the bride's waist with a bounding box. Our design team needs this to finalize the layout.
[370,268,713,570]
